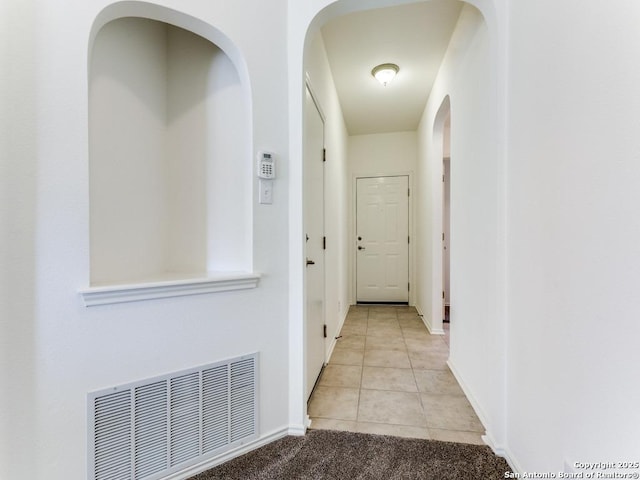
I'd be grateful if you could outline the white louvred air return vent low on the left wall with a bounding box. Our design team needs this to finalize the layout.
[89,353,258,480]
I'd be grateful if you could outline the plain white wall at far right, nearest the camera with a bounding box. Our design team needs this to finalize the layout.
[504,0,640,471]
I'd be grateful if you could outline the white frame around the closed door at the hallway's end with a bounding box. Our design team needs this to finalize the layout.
[349,171,416,305]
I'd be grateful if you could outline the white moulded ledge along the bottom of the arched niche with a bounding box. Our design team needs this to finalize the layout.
[79,272,260,307]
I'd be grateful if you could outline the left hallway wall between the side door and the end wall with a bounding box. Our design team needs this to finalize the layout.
[304,32,350,358]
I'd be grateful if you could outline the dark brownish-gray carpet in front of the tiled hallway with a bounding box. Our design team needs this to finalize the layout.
[190,430,511,480]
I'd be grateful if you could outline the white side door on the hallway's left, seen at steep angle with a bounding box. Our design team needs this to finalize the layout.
[304,89,325,398]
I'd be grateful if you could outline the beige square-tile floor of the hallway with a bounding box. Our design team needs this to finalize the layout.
[308,305,484,444]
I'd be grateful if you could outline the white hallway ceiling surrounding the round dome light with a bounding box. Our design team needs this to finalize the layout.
[322,0,463,135]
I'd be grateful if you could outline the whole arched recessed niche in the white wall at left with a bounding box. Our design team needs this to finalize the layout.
[85,17,257,303]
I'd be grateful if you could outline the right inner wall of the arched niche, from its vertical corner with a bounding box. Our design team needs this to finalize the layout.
[167,27,254,272]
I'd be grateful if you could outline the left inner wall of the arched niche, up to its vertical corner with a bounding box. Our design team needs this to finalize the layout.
[88,18,171,284]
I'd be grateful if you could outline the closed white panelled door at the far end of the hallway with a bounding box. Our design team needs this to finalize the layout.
[356,176,409,303]
